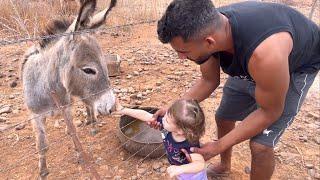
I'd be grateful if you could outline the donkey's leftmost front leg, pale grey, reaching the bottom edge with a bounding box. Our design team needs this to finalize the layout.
[32,114,49,179]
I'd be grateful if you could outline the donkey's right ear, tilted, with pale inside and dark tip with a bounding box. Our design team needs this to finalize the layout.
[88,0,117,29]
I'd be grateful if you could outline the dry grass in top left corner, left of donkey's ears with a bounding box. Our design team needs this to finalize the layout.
[0,0,76,37]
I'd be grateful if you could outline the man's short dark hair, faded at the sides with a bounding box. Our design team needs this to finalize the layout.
[157,0,221,43]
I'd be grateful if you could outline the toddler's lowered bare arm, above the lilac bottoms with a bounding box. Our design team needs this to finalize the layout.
[167,153,206,178]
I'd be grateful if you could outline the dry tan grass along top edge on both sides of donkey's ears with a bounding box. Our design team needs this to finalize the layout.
[0,0,171,39]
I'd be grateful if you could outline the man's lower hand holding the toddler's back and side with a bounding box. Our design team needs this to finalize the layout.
[190,141,222,161]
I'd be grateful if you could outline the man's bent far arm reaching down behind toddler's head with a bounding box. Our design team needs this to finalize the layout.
[182,56,220,101]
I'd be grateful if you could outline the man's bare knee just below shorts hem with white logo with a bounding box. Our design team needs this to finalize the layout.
[250,140,274,160]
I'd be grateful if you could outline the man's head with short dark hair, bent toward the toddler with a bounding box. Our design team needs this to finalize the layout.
[157,0,222,64]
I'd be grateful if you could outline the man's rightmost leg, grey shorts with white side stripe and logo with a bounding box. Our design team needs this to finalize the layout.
[250,73,317,180]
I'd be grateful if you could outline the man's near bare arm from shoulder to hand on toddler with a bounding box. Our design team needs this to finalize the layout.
[191,33,292,159]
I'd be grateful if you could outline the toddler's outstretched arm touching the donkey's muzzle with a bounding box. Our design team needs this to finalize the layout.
[113,101,153,121]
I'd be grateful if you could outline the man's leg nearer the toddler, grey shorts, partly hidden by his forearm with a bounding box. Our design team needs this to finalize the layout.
[207,77,257,176]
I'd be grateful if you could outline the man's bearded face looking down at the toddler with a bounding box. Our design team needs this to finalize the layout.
[170,37,214,64]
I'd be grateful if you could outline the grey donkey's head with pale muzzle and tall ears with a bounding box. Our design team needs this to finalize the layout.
[40,0,116,116]
